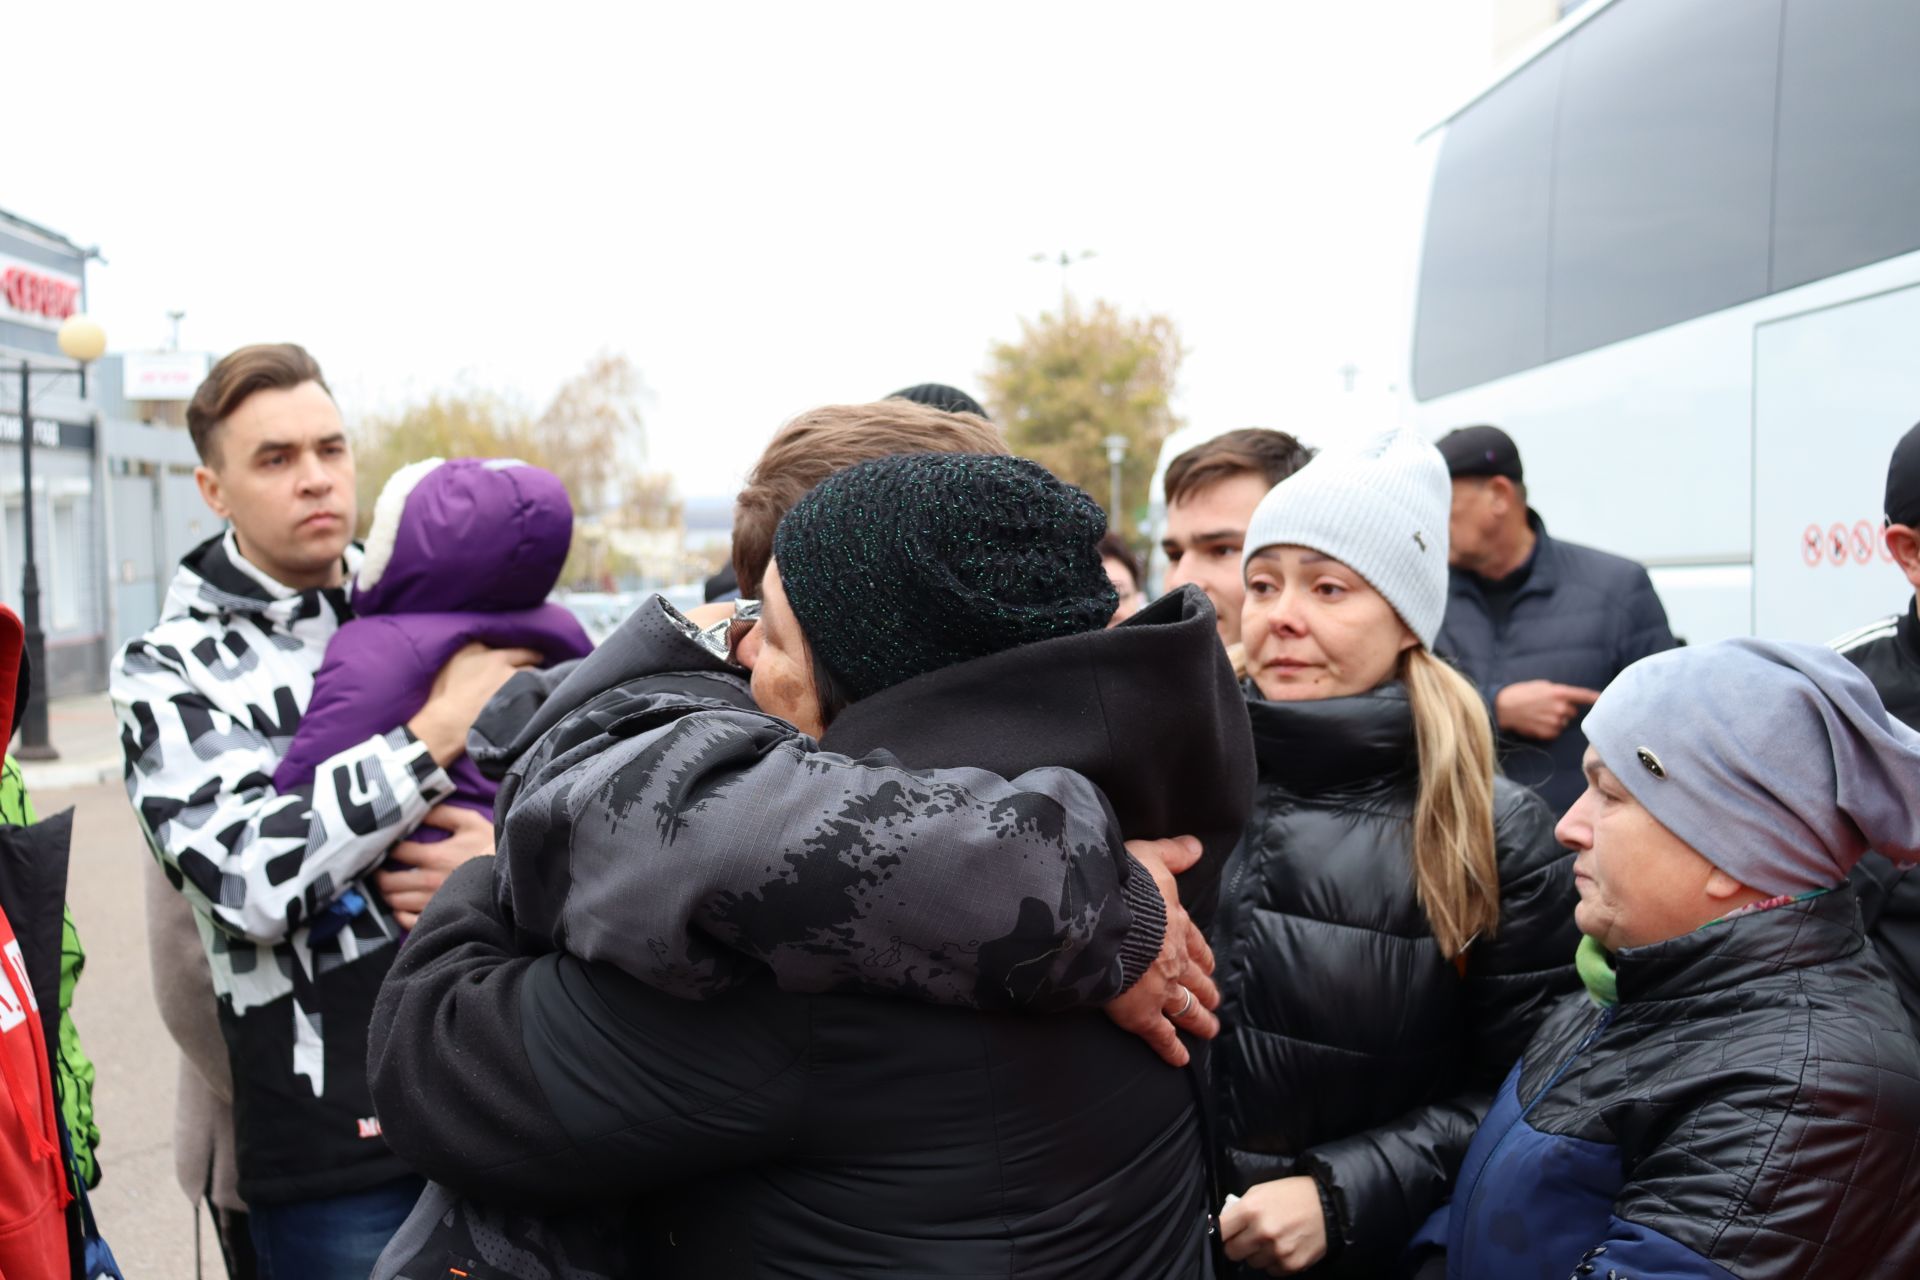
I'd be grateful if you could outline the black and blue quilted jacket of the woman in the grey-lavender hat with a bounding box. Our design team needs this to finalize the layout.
[1443,887,1920,1280]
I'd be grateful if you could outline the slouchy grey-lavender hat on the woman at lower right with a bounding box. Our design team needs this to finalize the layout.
[1582,639,1920,894]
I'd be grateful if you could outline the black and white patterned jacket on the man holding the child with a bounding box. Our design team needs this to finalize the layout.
[109,532,453,1203]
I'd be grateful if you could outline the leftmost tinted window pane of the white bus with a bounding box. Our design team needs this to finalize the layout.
[1413,50,1563,399]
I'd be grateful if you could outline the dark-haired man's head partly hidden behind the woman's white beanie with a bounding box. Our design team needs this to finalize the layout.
[1160,426,1313,652]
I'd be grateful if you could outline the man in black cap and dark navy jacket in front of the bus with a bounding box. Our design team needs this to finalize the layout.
[1434,426,1676,814]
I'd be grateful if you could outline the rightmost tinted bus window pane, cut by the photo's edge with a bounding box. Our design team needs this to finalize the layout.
[1772,0,1920,290]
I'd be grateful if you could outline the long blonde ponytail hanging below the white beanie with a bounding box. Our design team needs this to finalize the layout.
[1400,647,1500,961]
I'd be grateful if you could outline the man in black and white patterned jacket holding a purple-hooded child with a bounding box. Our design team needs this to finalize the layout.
[109,344,530,1280]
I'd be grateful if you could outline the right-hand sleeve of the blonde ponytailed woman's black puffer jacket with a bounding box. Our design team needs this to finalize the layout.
[1306,781,1580,1274]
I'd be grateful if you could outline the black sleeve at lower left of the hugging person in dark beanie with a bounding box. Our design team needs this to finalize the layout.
[369,858,808,1207]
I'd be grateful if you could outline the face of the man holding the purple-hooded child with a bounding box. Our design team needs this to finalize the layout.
[194,382,355,589]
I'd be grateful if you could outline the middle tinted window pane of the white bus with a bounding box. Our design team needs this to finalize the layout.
[1548,0,1782,359]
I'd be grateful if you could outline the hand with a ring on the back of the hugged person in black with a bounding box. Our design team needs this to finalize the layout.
[1106,835,1219,1067]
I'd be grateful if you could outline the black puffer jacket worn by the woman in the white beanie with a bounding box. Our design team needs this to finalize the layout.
[1213,685,1578,1276]
